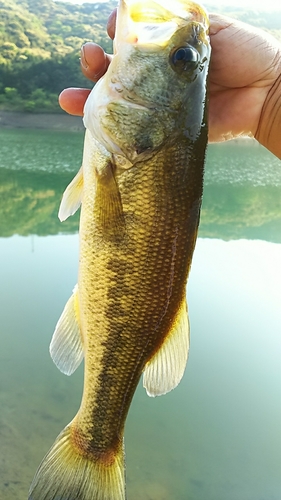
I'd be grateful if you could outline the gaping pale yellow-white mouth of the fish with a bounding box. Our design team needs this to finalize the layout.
[115,0,209,52]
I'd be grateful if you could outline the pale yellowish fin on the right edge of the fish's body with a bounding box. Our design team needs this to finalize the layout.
[143,298,189,396]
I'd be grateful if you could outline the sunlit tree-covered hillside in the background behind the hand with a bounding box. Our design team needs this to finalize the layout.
[0,0,281,112]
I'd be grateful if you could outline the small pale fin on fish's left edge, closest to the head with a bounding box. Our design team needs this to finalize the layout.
[58,167,83,222]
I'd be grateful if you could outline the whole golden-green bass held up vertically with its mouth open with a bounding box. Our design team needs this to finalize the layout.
[28,0,211,500]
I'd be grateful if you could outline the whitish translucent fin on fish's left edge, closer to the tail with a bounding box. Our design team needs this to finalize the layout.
[50,285,84,375]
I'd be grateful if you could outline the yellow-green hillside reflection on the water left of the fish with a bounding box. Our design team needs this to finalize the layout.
[0,164,79,237]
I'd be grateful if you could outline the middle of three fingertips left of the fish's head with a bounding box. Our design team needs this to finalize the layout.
[80,42,111,82]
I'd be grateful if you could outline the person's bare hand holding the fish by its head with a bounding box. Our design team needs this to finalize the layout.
[59,11,281,158]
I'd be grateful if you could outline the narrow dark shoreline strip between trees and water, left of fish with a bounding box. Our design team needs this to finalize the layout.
[0,110,84,132]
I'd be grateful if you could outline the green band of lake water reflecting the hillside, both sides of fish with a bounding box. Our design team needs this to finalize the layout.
[0,131,281,242]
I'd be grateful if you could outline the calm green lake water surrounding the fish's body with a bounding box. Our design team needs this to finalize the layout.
[0,129,281,500]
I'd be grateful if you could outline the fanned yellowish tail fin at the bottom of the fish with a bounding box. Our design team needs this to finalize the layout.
[28,425,126,500]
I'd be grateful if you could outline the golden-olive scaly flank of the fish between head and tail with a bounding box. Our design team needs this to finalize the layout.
[74,141,202,453]
